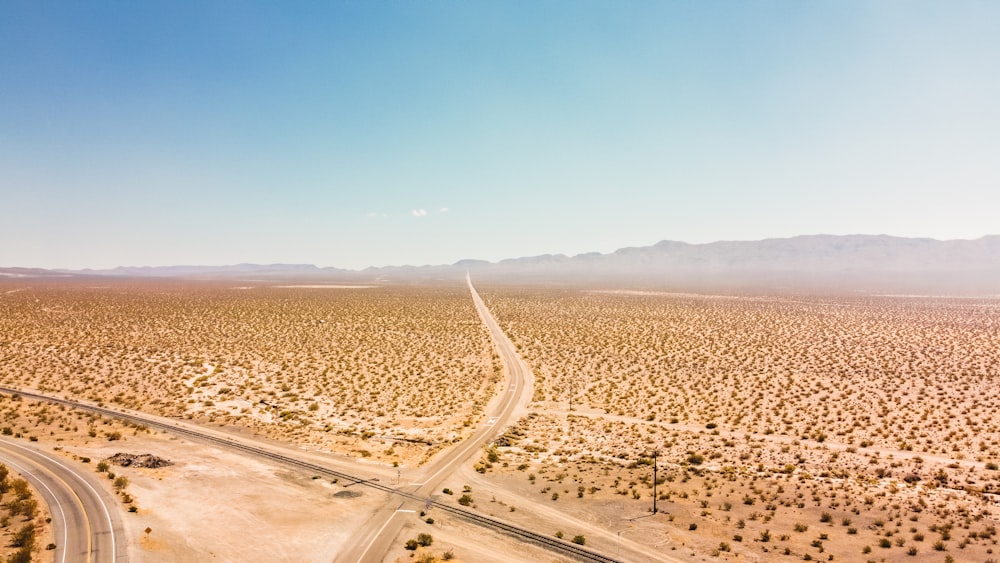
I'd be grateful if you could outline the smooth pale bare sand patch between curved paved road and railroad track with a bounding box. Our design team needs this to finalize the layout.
[74,434,392,561]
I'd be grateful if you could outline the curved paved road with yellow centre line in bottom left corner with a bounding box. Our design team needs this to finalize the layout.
[0,437,128,563]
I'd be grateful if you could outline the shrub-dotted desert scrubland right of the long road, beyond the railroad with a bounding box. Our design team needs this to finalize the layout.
[477,289,1000,562]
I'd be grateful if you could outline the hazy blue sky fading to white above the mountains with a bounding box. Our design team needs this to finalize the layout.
[0,0,1000,268]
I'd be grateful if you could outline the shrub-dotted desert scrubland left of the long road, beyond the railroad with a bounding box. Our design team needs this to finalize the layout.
[0,280,500,465]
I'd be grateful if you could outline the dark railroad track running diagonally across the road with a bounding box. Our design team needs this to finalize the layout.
[0,386,619,563]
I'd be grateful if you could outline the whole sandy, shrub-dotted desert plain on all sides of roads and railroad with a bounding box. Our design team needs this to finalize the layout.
[0,279,1000,562]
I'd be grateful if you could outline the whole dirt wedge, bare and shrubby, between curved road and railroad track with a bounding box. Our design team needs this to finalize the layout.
[0,396,385,562]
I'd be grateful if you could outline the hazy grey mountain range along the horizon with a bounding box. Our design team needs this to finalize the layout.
[0,235,1000,295]
